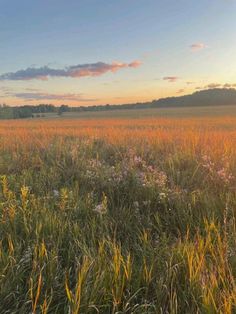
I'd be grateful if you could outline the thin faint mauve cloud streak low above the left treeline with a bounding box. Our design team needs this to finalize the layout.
[11,92,99,101]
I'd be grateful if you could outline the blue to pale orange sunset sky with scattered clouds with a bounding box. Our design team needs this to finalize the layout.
[0,0,236,106]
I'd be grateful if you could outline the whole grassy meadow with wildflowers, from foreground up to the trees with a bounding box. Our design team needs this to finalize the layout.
[0,107,236,314]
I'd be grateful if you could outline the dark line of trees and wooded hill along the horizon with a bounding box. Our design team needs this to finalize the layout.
[0,88,236,119]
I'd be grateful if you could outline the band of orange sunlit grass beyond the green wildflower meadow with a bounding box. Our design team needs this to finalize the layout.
[0,117,236,154]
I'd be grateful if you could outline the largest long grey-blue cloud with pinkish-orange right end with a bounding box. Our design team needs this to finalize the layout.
[0,60,141,81]
